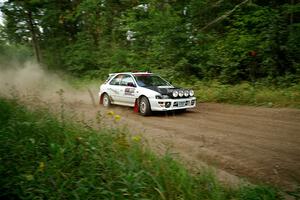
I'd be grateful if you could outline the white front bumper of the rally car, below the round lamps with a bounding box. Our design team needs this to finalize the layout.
[149,97,196,111]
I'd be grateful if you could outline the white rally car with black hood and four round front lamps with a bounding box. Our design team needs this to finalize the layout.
[99,72,196,115]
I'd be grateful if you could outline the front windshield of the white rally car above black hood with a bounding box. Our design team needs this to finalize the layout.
[134,74,171,87]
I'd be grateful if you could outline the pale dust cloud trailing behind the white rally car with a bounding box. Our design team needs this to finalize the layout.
[0,62,98,104]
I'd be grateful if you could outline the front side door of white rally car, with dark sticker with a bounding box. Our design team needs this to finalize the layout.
[121,74,137,106]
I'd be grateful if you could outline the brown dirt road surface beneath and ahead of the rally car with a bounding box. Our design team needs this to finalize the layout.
[71,103,300,190]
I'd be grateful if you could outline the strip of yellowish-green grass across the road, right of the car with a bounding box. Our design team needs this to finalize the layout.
[180,81,300,109]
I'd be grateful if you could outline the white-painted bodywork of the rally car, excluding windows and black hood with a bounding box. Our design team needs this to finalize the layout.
[99,72,196,111]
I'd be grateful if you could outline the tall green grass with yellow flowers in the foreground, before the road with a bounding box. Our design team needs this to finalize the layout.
[0,99,282,200]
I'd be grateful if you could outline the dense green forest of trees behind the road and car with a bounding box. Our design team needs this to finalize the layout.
[0,0,300,85]
